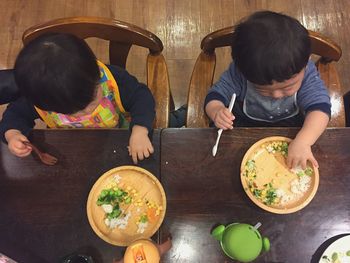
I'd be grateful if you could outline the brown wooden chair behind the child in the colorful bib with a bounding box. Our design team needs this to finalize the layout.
[22,17,171,128]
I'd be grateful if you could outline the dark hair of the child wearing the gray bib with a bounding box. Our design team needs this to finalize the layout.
[232,11,311,85]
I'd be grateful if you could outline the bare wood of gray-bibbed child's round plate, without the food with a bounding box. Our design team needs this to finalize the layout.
[241,136,319,214]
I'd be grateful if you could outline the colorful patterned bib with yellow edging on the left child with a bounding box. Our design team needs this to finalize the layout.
[35,61,129,128]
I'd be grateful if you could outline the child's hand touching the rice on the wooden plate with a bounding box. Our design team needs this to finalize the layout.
[287,139,318,169]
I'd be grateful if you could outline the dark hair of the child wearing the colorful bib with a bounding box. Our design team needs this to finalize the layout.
[15,33,100,114]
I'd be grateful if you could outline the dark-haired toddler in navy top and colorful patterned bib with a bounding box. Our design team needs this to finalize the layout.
[0,33,155,163]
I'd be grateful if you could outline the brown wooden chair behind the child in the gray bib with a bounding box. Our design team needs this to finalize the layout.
[186,27,345,128]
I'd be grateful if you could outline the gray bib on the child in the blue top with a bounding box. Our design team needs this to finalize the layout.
[243,81,299,122]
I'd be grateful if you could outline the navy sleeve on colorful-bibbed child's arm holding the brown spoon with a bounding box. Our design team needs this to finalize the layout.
[0,97,39,143]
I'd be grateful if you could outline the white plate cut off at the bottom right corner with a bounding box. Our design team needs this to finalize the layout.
[319,235,350,263]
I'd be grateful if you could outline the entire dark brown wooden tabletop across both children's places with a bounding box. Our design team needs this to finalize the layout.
[0,128,350,263]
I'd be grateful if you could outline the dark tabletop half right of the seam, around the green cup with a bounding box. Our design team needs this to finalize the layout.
[161,128,350,263]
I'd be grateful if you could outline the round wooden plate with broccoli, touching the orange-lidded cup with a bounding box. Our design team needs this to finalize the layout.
[87,166,166,246]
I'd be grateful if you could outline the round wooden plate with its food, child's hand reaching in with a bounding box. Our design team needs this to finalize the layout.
[241,136,319,214]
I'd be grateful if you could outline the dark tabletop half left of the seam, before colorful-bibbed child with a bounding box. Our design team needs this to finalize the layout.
[0,130,160,263]
